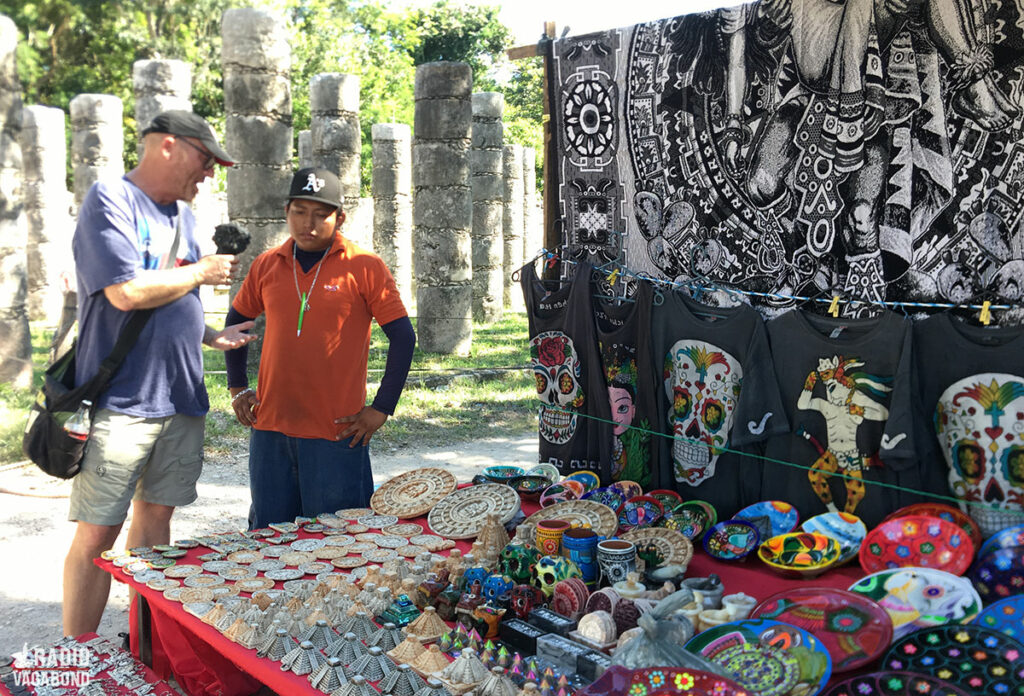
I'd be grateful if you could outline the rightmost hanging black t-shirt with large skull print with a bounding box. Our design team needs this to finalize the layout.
[914,313,1024,536]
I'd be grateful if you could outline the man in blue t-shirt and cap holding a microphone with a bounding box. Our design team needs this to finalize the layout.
[63,111,254,636]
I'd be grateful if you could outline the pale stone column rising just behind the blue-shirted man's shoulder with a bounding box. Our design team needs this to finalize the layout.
[70,94,125,206]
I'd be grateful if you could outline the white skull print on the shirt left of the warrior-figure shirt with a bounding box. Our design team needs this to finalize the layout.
[663,340,743,486]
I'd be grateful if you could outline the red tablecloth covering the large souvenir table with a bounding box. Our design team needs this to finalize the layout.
[95,502,863,696]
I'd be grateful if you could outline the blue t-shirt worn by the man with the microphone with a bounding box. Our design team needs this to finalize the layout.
[72,177,210,418]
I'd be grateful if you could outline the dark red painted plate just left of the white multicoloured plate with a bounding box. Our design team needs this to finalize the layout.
[751,588,893,672]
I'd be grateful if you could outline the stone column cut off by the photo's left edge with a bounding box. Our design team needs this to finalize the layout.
[0,14,32,389]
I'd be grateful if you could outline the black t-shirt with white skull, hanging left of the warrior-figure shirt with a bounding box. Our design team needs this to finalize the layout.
[651,293,788,519]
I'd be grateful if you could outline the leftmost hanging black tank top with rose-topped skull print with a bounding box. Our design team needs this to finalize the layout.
[520,263,611,482]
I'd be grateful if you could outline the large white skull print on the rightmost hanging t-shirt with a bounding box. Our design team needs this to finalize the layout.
[935,374,1024,536]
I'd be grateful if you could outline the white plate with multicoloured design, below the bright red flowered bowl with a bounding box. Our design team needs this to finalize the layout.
[849,568,981,640]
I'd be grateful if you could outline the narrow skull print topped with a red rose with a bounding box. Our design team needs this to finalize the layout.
[529,331,584,444]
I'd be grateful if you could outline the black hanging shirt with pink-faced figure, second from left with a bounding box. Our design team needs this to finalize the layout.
[594,280,657,488]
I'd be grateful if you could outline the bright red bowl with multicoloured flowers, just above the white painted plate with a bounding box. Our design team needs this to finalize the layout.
[860,515,974,575]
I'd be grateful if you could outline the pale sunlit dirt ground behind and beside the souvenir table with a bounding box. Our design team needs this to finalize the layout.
[0,432,538,656]
